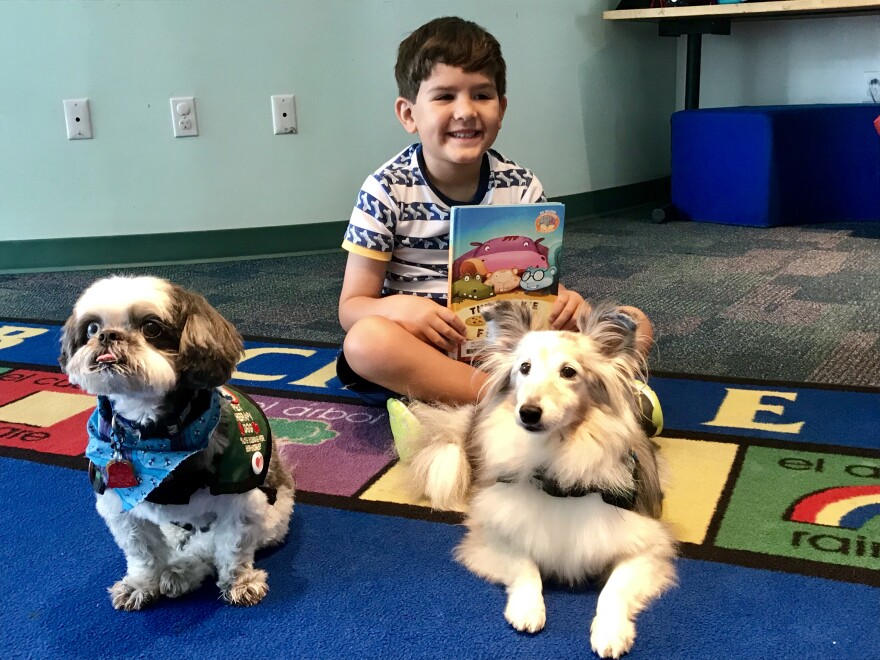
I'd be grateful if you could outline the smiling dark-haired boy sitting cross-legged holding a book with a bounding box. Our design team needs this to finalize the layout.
[337,17,651,436]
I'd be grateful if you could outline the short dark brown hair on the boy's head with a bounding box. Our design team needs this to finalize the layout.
[394,16,507,101]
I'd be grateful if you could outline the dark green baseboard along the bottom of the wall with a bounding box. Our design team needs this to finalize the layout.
[0,177,669,272]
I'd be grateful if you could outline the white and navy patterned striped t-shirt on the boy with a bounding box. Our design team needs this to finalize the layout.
[342,144,546,304]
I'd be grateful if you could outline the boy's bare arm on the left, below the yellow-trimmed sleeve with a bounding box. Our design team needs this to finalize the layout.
[339,252,467,351]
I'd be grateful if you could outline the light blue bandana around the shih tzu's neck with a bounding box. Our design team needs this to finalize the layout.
[86,390,221,511]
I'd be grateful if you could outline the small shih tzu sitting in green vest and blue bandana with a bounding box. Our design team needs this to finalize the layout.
[59,277,294,610]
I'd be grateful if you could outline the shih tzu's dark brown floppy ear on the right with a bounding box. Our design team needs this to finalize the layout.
[171,285,244,389]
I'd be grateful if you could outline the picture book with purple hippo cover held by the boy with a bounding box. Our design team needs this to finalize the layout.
[449,202,565,362]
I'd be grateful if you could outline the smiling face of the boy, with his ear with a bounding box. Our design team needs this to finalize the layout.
[395,64,507,184]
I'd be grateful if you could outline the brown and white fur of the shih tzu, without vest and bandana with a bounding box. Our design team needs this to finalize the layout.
[59,277,294,610]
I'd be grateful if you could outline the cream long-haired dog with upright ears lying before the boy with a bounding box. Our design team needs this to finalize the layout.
[409,302,676,658]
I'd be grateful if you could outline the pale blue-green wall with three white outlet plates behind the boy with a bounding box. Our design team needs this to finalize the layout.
[0,0,676,240]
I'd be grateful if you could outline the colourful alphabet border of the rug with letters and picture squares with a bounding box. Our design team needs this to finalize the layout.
[0,319,880,586]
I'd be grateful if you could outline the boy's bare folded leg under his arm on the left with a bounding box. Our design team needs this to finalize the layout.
[343,316,486,403]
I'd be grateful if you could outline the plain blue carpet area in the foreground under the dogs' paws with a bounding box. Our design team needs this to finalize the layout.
[0,458,880,659]
